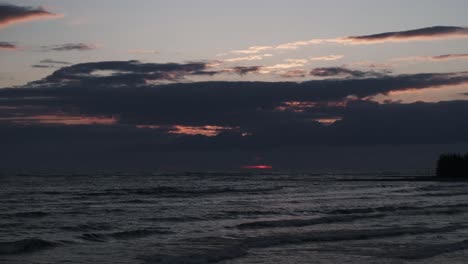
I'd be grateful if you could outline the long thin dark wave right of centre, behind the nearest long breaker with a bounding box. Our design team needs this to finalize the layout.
[236,214,386,229]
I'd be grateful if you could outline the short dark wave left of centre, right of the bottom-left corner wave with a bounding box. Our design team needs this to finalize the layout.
[80,229,172,242]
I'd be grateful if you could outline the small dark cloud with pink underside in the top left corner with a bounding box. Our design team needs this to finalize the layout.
[0,4,60,27]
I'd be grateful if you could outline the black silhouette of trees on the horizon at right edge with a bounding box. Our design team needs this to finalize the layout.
[436,153,468,179]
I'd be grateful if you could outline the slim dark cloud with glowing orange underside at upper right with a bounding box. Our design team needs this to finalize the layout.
[345,26,468,43]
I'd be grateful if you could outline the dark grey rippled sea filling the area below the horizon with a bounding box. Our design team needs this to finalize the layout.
[0,173,468,264]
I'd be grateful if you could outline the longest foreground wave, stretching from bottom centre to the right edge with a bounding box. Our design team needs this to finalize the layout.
[143,226,466,264]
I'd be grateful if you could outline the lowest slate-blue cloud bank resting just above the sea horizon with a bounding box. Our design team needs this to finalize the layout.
[0,102,468,170]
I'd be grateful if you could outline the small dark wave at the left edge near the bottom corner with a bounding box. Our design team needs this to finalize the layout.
[0,238,58,255]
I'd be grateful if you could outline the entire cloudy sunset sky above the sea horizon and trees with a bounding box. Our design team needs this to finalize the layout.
[0,0,468,170]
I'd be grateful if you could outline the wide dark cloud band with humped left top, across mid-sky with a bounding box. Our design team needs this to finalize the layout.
[0,65,468,128]
